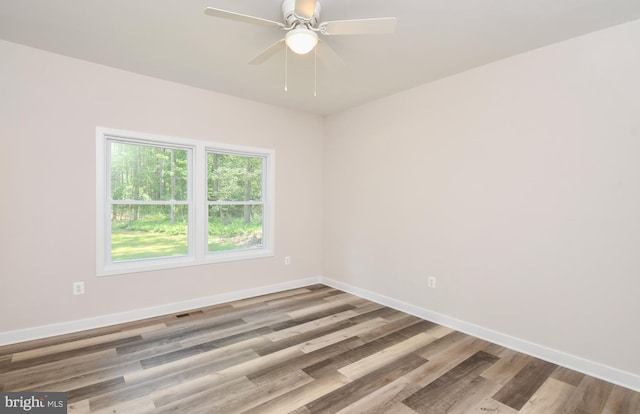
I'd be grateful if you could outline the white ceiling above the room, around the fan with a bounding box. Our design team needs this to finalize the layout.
[0,0,640,115]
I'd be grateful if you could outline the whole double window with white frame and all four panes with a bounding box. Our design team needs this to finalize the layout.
[96,128,274,275]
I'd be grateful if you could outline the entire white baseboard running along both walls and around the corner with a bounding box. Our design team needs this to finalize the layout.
[0,277,640,391]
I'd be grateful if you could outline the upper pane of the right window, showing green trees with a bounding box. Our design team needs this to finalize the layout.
[207,152,262,201]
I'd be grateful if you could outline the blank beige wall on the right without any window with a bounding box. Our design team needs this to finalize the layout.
[323,22,640,374]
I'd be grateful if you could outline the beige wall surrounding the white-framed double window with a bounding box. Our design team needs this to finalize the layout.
[0,41,323,332]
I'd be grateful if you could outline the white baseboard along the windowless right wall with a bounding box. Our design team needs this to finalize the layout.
[320,277,640,391]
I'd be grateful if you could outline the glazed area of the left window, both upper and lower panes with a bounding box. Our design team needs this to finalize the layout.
[107,138,193,263]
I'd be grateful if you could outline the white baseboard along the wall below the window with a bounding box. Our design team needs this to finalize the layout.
[0,277,320,346]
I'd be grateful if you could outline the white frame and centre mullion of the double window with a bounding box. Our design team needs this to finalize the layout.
[96,127,275,276]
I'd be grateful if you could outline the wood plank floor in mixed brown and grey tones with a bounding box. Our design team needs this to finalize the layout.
[0,285,640,414]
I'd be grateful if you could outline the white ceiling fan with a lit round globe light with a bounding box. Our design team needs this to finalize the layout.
[204,0,396,65]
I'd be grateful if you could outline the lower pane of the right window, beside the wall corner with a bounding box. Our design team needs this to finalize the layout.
[209,205,263,252]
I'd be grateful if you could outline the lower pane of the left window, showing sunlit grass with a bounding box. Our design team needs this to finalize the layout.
[111,204,189,262]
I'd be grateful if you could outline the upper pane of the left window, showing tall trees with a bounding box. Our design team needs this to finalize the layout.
[111,141,188,201]
